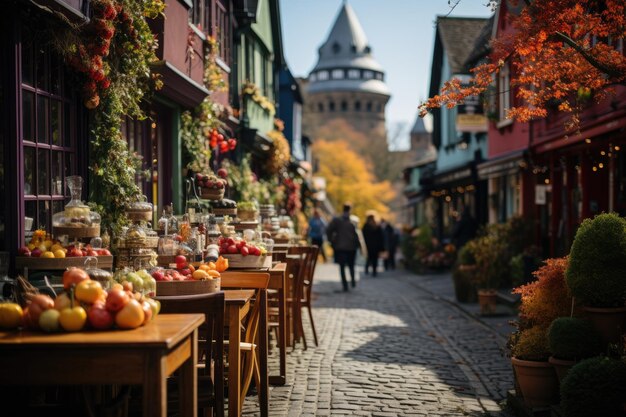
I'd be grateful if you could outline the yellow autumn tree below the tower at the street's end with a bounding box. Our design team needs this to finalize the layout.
[313,140,395,222]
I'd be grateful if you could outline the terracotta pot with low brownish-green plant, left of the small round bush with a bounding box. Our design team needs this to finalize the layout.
[511,326,559,407]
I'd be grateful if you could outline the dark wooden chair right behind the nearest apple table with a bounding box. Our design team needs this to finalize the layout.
[155,291,224,417]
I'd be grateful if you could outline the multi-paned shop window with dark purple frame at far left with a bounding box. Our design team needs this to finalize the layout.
[19,27,77,236]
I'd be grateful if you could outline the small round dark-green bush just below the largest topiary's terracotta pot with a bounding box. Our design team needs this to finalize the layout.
[548,317,602,381]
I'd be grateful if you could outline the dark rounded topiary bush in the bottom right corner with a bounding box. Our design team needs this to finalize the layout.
[561,357,626,417]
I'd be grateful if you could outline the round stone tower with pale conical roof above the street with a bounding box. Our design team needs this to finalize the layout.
[302,2,389,143]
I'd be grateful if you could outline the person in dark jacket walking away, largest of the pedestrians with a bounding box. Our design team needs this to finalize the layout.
[326,203,359,291]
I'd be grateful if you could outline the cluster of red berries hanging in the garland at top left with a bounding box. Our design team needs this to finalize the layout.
[70,0,121,109]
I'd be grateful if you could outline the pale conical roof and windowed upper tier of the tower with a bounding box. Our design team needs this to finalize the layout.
[309,2,389,96]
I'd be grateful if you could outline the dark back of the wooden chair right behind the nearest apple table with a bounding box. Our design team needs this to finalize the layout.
[155,291,224,417]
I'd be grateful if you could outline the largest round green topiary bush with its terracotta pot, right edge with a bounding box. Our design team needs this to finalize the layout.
[566,213,626,343]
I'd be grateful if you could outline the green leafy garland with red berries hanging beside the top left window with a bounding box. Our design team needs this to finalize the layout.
[50,0,165,233]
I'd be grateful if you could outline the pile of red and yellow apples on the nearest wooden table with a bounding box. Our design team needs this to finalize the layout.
[0,268,160,332]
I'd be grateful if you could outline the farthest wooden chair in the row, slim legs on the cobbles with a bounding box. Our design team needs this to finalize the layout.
[289,246,319,349]
